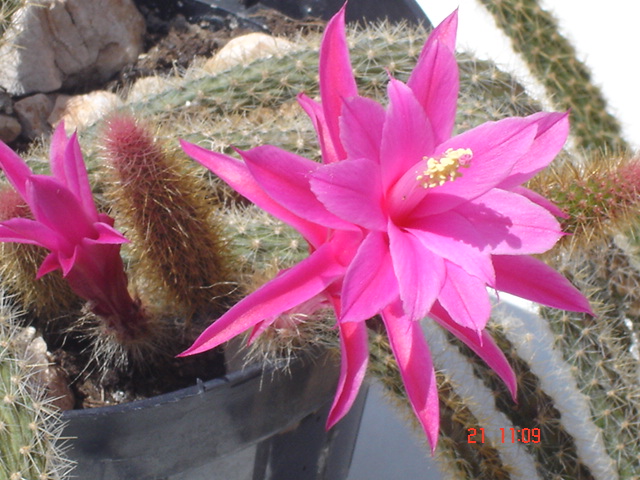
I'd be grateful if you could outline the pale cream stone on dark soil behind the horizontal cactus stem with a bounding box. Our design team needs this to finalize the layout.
[203,32,294,73]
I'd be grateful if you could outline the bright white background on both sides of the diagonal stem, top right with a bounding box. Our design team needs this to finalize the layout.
[417,0,640,149]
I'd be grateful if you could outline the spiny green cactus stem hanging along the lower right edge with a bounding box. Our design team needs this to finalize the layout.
[542,242,640,480]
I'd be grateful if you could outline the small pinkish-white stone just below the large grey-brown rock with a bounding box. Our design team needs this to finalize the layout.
[47,90,123,133]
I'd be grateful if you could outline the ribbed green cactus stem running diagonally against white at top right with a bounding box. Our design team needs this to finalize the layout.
[481,0,629,153]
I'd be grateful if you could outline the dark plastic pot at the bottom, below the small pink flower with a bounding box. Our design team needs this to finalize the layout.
[64,348,366,480]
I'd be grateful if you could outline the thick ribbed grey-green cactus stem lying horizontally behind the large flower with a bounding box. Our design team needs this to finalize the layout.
[33,23,540,177]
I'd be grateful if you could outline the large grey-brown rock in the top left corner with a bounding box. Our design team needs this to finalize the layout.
[0,0,145,95]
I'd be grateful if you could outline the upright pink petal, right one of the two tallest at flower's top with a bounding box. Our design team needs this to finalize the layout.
[407,10,459,144]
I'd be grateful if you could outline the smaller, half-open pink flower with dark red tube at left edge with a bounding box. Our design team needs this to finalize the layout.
[0,123,140,337]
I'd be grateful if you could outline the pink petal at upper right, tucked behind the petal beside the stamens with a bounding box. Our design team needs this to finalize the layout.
[500,112,569,190]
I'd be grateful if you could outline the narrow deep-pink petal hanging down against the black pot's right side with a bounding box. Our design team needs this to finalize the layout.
[326,322,369,429]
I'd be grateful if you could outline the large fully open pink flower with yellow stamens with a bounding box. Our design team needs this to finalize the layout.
[183,8,590,448]
